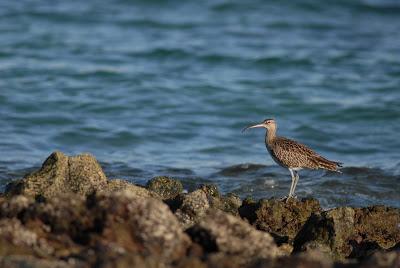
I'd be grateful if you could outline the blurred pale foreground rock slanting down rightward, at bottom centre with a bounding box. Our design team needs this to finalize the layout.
[187,209,283,263]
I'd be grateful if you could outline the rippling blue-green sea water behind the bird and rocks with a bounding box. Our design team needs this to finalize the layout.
[0,0,400,207]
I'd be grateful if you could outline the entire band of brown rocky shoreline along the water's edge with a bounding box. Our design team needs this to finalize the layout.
[0,152,400,268]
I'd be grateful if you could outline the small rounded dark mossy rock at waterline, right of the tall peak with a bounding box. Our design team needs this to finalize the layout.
[146,176,183,200]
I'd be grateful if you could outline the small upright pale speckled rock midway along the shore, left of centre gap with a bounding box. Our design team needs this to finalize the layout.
[175,189,210,228]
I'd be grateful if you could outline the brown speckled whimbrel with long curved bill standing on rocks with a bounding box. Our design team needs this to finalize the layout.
[243,119,342,200]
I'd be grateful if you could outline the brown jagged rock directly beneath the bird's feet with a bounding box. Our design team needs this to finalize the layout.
[239,199,321,244]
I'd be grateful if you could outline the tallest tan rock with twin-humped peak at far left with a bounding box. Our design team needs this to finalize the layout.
[6,152,107,198]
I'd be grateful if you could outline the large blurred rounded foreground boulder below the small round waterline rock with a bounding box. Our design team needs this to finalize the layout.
[94,191,190,262]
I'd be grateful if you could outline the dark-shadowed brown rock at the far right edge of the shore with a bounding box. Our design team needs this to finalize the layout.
[294,206,400,260]
